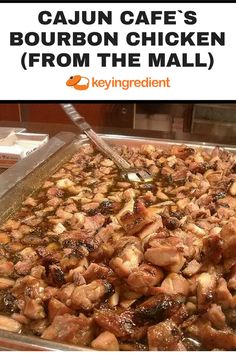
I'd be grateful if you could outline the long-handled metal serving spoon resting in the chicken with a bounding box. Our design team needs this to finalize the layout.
[61,104,152,183]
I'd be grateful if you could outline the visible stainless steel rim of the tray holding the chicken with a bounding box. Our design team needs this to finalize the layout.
[0,132,236,351]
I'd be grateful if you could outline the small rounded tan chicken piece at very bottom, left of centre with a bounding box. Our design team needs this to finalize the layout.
[91,331,119,351]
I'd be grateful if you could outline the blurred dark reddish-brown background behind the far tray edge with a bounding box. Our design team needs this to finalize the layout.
[0,103,236,143]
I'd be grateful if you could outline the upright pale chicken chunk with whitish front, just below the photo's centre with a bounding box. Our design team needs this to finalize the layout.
[109,237,143,277]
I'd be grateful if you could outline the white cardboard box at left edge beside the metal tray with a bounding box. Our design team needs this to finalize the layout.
[0,131,48,168]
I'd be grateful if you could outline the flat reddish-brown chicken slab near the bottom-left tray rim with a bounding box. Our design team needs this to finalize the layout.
[41,314,94,346]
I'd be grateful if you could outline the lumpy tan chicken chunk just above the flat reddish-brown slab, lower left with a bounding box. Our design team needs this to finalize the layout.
[71,279,112,310]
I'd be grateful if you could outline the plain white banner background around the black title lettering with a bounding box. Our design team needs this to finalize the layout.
[0,3,236,101]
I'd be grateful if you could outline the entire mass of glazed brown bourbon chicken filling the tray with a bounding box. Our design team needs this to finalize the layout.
[0,144,236,351]
